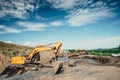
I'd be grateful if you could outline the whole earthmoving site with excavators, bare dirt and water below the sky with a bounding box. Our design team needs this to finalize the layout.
[0,42,120,80]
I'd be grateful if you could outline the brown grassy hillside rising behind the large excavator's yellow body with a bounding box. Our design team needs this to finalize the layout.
[0,41,33,57]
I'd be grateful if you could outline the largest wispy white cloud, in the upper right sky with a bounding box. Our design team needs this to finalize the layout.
[66,8,115,26]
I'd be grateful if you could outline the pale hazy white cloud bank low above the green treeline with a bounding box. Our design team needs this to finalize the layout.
[62,36,120,49]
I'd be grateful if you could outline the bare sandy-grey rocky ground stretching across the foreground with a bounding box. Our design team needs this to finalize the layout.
[0,55,120,80]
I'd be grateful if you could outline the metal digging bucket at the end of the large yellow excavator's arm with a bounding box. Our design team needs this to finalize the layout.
[53,61,63,74]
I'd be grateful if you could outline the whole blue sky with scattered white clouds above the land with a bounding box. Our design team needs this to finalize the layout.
[0,0,120,49]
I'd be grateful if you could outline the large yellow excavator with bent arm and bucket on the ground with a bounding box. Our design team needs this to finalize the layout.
[1,42,63,77]
